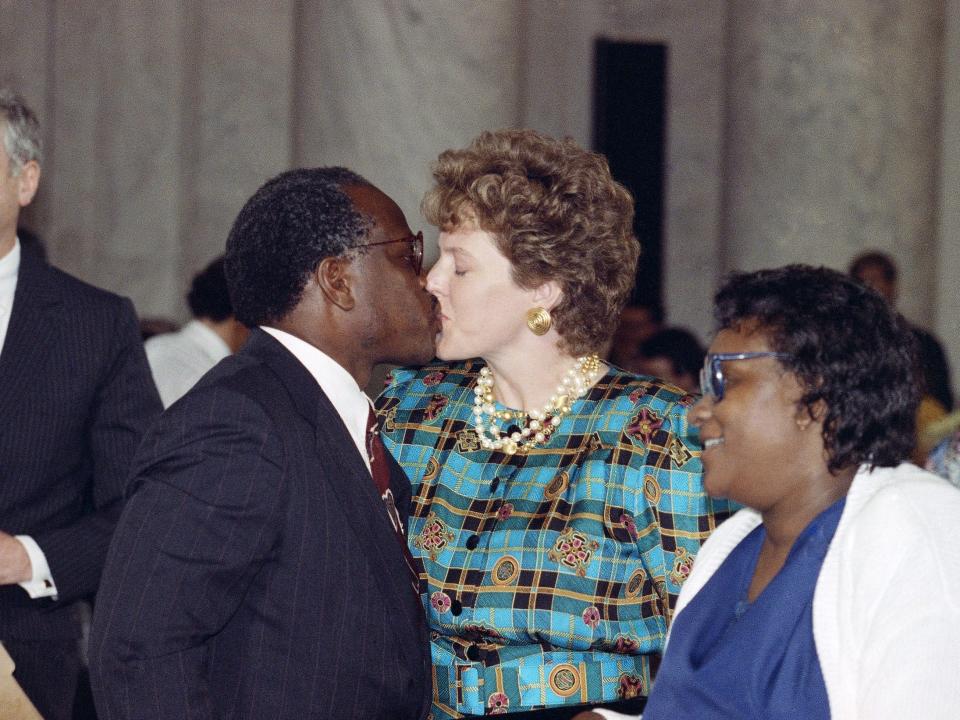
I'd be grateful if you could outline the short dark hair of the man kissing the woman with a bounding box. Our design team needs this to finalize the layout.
[224,167,371,327]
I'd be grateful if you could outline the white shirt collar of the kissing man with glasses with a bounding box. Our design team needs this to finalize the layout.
[261,326,373,469]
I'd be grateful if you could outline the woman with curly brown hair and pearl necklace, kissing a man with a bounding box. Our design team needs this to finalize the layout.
[378,130,727,719]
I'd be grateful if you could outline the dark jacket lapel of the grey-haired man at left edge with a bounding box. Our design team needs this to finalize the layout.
[0,250,62,417]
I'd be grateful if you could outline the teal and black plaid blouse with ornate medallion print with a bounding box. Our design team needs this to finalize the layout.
[377,360,730,718]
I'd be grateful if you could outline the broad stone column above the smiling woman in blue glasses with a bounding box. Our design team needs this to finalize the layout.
[721,0,944,323]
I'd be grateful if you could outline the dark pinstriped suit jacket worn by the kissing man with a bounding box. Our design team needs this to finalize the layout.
[90,330,431,720]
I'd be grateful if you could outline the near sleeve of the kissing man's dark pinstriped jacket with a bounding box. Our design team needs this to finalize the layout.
[90,387,286,720]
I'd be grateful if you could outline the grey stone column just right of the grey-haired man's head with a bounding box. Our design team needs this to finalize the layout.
[48,0,188,315]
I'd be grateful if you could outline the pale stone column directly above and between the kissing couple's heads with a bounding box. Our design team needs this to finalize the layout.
[295,0,523,253]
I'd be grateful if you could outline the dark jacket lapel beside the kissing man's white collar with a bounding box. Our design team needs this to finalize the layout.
[248,330,422,647]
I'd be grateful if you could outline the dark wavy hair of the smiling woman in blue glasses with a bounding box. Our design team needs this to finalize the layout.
[715,265,919,472]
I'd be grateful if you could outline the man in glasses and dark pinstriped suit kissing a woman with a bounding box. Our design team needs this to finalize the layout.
[90,168,437,720]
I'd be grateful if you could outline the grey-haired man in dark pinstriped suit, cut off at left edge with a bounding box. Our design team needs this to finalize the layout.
[0,89,160,720]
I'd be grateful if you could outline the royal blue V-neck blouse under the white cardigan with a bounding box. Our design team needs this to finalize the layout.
[643,499,844,720]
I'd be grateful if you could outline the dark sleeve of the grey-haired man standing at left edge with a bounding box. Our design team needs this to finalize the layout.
[34,298,162,602]
